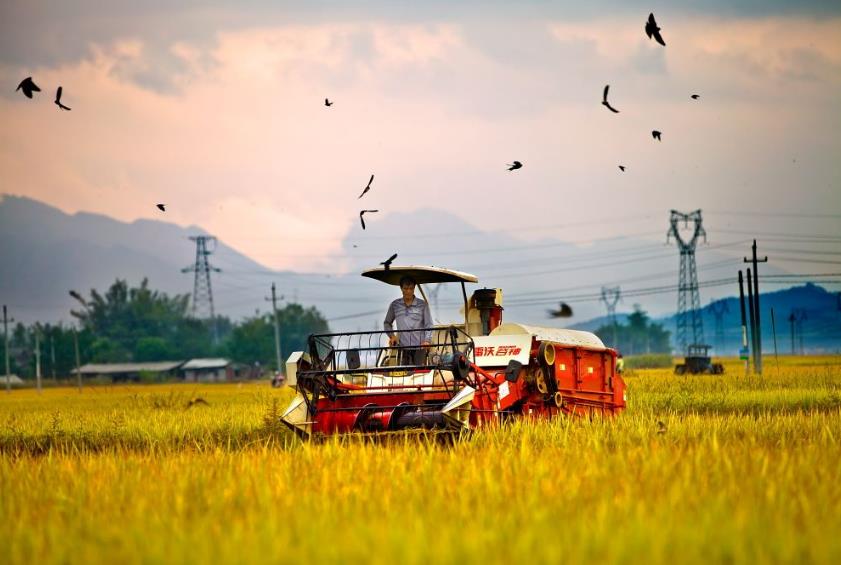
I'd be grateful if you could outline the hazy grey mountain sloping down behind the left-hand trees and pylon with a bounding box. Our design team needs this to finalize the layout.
[0,195,265,323]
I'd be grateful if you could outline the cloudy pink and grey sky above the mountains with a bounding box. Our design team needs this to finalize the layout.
[0,0,841,312]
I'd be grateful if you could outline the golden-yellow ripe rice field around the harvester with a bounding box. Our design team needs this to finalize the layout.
[0,358,841,564]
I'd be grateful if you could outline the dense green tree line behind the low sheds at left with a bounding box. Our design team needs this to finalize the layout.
[4,279,329,378]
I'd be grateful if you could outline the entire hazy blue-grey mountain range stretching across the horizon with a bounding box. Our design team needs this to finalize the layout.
[0,195,841,352]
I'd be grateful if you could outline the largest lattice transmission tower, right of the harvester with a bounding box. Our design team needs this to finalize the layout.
[666,210,707,351]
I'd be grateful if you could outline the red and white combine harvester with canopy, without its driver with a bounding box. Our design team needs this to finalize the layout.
[282,266,625,438]
